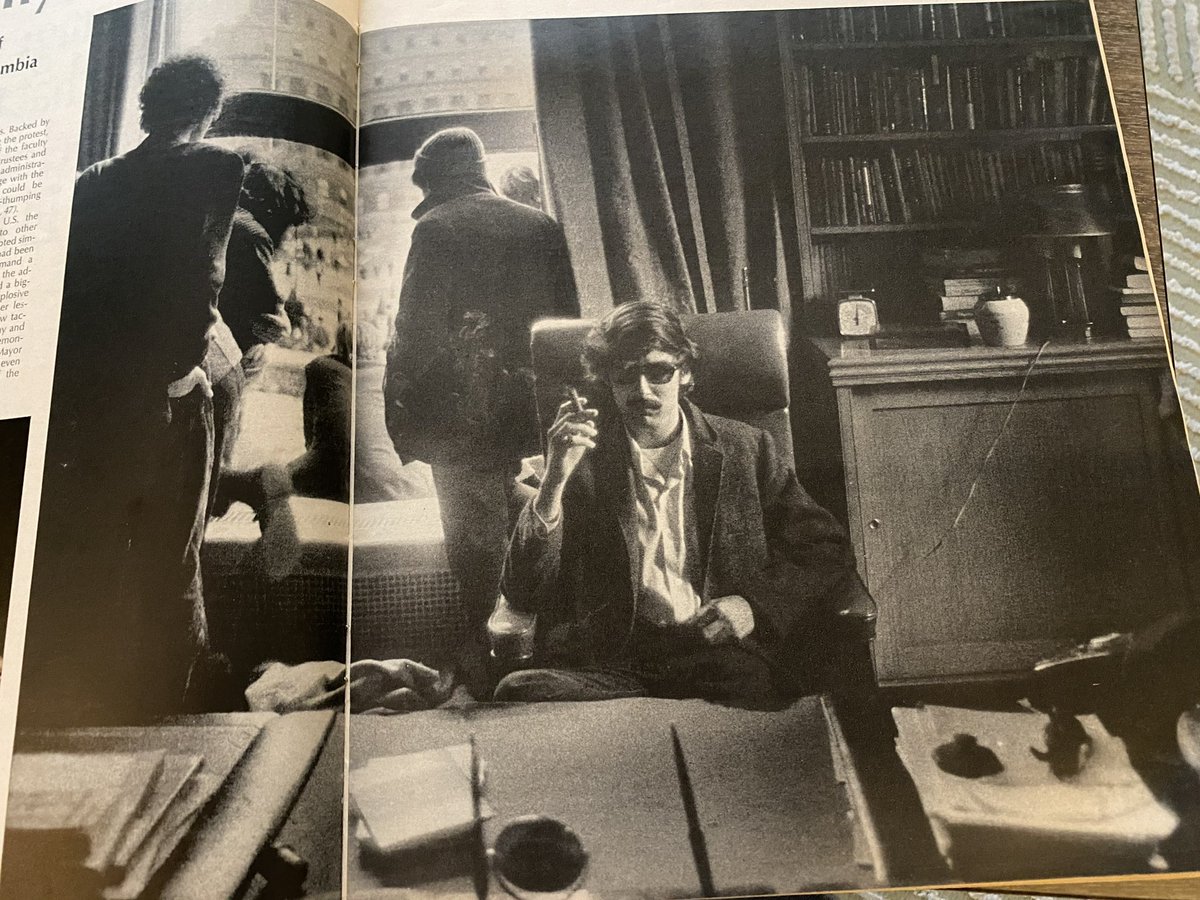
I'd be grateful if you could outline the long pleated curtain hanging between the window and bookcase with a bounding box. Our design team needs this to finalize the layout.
[532,13,798,322]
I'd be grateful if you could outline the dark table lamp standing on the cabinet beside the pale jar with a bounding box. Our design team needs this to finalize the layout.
[1022,184,1115,341]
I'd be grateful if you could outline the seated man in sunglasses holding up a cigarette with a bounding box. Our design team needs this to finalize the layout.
[494,301,865,707]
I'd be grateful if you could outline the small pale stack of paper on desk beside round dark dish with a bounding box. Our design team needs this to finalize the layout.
[349,744,493,853]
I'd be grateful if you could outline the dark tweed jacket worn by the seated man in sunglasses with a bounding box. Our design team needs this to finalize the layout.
[503,401,865,670]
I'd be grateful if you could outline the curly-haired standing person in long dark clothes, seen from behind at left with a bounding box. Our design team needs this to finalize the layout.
[20,56,242,725]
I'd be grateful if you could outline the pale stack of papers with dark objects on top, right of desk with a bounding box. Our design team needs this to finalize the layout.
[892,707,1178,877]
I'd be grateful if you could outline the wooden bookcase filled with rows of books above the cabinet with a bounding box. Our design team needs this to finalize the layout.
[776,0,1126,330]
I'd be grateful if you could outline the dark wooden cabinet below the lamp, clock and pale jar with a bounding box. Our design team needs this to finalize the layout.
[820,340,1194,684]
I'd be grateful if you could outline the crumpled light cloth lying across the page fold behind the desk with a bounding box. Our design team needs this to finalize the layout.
[246,659,454,715]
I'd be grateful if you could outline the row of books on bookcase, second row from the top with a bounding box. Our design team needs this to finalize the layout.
[796,54,1112,137]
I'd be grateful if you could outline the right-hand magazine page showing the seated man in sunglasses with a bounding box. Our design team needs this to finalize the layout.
[346,0,1200,896]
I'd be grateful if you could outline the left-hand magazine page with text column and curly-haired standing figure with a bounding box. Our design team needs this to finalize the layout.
[0,0,358,898]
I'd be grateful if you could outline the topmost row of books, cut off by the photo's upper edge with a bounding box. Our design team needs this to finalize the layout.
[793,0,1093,43]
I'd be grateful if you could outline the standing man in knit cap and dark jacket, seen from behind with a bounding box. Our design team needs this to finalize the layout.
[384,128,578,643]
